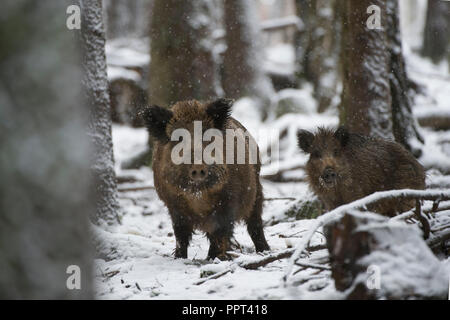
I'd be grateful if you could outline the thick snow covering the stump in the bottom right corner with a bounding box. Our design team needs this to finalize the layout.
[353,213,449,298]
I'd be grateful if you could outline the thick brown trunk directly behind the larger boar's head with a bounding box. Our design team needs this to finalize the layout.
[149,0,220,106]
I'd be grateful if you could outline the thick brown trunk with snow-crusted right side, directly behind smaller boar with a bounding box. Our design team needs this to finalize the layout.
[340,0,394,139]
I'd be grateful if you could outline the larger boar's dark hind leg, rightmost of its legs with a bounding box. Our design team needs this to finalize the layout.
[247,185,270,252]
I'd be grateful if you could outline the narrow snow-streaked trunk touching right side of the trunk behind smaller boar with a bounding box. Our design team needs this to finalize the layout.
[387,1,424,157]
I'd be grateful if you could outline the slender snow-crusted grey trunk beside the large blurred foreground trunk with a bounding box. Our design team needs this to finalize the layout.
[80,0,119,224]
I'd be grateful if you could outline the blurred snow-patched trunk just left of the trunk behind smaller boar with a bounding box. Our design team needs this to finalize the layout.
[295,0,342,112]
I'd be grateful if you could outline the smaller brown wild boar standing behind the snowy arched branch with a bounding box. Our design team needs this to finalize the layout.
[297,127,425,216]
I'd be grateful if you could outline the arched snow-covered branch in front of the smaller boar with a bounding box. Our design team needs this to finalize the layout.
[283,189,450,282]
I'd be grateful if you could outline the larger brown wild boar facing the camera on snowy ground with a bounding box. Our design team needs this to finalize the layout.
[143,99,269,259]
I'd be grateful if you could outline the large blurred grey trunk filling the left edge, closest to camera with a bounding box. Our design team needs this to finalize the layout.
[0,0,95,299]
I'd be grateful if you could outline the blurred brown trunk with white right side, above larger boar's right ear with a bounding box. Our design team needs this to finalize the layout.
[222,0,274,118]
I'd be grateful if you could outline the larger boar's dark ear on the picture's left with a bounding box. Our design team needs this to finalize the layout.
[142,106,173,142]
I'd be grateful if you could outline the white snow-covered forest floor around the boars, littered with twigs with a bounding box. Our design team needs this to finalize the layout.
[95,43,450,299]
